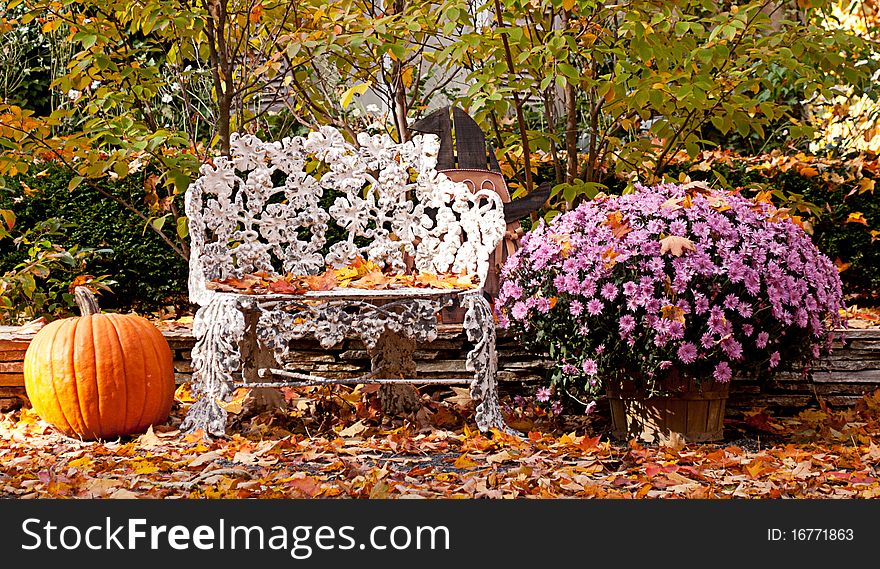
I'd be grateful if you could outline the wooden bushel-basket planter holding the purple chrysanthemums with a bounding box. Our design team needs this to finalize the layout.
[607,370,730,442]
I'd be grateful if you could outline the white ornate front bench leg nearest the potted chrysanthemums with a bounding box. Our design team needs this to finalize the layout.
[464,293,521,436]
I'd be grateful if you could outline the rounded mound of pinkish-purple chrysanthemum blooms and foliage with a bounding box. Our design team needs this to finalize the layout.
[497,184,844,400]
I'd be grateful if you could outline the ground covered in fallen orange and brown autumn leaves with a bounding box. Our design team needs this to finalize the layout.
[0,388,880,498]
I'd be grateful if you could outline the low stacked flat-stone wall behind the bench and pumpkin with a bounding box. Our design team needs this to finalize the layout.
[0,325,880,410]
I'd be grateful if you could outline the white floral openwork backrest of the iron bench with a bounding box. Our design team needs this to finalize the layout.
[186,127,505,304]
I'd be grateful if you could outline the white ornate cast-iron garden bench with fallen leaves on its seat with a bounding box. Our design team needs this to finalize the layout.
[181,127,512,436]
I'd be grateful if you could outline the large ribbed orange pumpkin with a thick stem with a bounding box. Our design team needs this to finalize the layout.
[24,287,174,439]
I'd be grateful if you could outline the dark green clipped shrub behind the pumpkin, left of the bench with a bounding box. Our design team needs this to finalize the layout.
[0,164,187,310]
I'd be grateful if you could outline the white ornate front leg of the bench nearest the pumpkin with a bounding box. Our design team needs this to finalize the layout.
[180,295,245,436]
